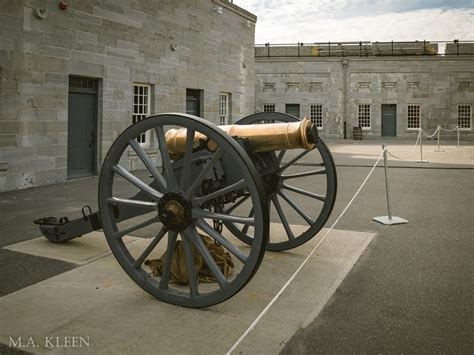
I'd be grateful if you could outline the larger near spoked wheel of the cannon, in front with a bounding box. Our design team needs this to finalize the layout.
[98,114,269,308]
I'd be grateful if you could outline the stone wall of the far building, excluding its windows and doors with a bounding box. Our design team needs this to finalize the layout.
[255,56,474,140]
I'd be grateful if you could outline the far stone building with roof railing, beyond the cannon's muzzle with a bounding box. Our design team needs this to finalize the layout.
[255,41,474,140]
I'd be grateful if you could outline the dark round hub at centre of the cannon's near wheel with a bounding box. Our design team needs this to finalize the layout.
[158,192,192,232]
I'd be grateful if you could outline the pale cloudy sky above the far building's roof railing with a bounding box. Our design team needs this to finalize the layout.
[234,0,474,44]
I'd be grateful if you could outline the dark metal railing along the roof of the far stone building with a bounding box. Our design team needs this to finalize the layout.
[255,39,474,58]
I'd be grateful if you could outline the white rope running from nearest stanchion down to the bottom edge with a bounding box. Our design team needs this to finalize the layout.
[226,147,387,355]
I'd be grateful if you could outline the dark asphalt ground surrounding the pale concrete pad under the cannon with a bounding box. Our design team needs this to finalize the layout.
[0,141,474,354]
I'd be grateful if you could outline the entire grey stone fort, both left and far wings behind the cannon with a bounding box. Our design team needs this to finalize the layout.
[0,0,474,195]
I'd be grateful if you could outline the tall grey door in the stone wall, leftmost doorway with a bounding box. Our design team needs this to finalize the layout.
[67,77,98,179]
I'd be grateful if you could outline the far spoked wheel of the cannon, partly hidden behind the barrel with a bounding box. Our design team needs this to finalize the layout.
[225,112,337,251]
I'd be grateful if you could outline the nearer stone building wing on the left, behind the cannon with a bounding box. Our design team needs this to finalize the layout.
[0,0,256,191]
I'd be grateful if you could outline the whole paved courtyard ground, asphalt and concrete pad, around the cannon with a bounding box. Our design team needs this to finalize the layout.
[0,140,474,354]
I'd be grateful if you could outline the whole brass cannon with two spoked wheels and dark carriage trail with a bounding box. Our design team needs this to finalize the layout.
[35,112,337,308]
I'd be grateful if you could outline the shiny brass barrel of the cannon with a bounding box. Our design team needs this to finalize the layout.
[166,117,317,156]
